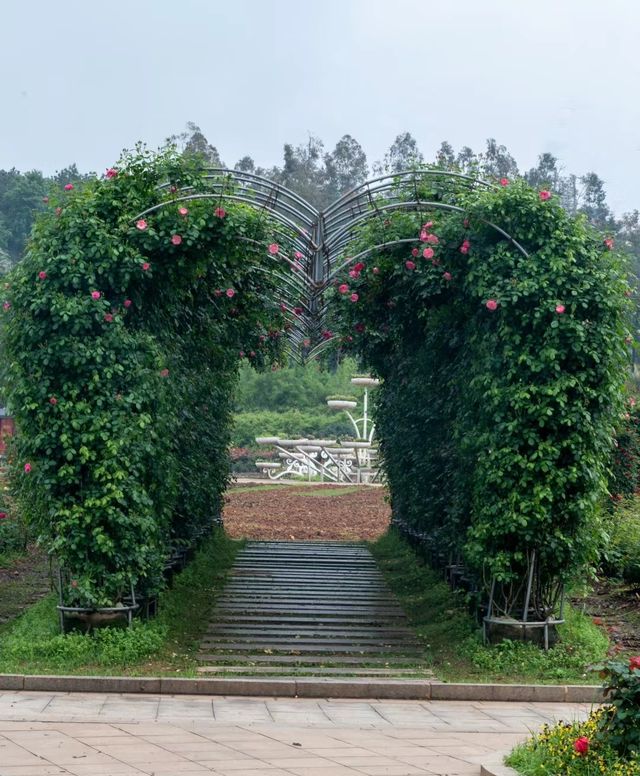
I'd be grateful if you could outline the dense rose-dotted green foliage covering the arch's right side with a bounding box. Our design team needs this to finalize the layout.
[335,180,628,581]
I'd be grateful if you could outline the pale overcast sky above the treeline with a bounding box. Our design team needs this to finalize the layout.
[0,0,640,212]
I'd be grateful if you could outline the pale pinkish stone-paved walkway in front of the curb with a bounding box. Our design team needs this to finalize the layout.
[0,692,588,776]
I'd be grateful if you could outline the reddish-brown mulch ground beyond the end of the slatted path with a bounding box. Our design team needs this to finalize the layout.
[224,484,391,541]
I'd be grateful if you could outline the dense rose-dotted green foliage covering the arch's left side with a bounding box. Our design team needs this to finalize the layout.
[3,152,284,606]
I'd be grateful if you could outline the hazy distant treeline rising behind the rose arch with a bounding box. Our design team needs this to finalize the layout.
[0,122,640,282]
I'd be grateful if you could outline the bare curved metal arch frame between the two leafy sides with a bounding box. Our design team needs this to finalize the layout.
[127,167,529,358]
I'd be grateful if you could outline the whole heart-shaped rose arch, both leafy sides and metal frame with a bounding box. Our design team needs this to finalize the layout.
[3,151,627,606]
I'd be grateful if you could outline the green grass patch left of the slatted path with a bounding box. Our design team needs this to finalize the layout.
[0,529,243,676]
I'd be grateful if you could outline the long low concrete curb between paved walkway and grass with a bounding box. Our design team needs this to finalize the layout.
[0,674,604,703]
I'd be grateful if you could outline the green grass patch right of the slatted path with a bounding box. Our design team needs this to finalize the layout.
[370,529,609,684]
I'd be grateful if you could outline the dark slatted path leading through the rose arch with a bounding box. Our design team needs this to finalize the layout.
[198,541,429,676]
